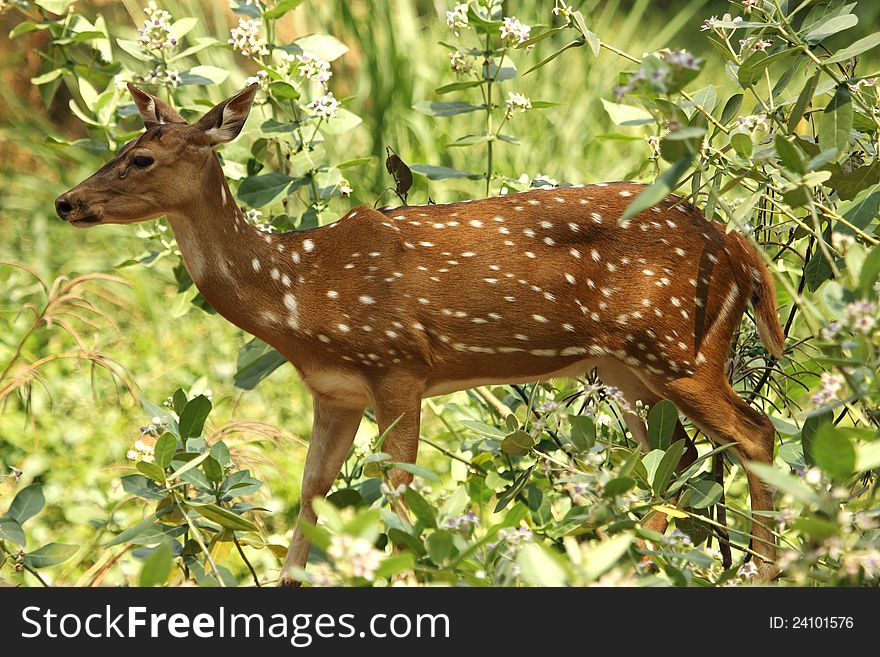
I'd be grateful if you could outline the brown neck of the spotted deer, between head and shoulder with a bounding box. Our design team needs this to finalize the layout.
[168,156,303,346]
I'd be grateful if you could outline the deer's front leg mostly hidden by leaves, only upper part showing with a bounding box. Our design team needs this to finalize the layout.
[374,377,424,487]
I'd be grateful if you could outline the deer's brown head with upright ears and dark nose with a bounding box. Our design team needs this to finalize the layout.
[55,84,257,227]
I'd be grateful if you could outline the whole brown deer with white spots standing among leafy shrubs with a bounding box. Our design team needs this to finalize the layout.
[55,85,784,584]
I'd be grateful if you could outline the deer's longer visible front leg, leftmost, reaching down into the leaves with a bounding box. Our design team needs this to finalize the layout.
[278,396,364,586]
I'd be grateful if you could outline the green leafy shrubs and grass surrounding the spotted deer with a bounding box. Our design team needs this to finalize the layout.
[0,0,880,586]
